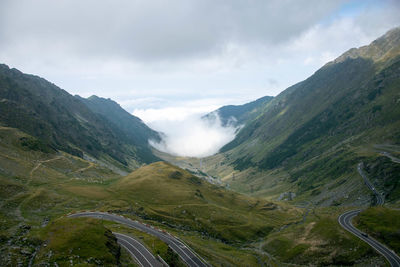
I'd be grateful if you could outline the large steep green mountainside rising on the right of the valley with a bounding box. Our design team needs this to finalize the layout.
[199,28,400,203]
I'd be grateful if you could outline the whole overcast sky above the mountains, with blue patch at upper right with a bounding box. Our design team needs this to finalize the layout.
[0,0,400,121]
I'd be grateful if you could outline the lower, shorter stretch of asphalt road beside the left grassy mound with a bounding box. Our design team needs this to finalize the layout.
[113,233,163,267]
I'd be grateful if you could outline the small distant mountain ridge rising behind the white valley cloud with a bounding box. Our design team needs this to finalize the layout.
[203,96,273,126]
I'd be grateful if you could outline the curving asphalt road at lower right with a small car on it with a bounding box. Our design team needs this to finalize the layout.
[338,210,400,267]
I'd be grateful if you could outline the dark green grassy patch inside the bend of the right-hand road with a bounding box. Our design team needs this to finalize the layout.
[355,207,400,254]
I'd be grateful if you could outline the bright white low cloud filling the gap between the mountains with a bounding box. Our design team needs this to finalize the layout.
[133,101,241,157]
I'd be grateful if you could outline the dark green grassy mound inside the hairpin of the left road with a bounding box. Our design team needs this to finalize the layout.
[33,218,120,266]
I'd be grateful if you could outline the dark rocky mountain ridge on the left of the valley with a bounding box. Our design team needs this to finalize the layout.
[0,65,157,173]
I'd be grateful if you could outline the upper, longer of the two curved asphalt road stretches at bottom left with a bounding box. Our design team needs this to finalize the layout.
[68,211,209,267]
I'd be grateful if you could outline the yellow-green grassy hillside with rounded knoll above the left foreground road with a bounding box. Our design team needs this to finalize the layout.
[0,127,301,265]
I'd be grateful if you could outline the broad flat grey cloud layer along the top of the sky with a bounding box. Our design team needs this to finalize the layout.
[0,0,343,62]
